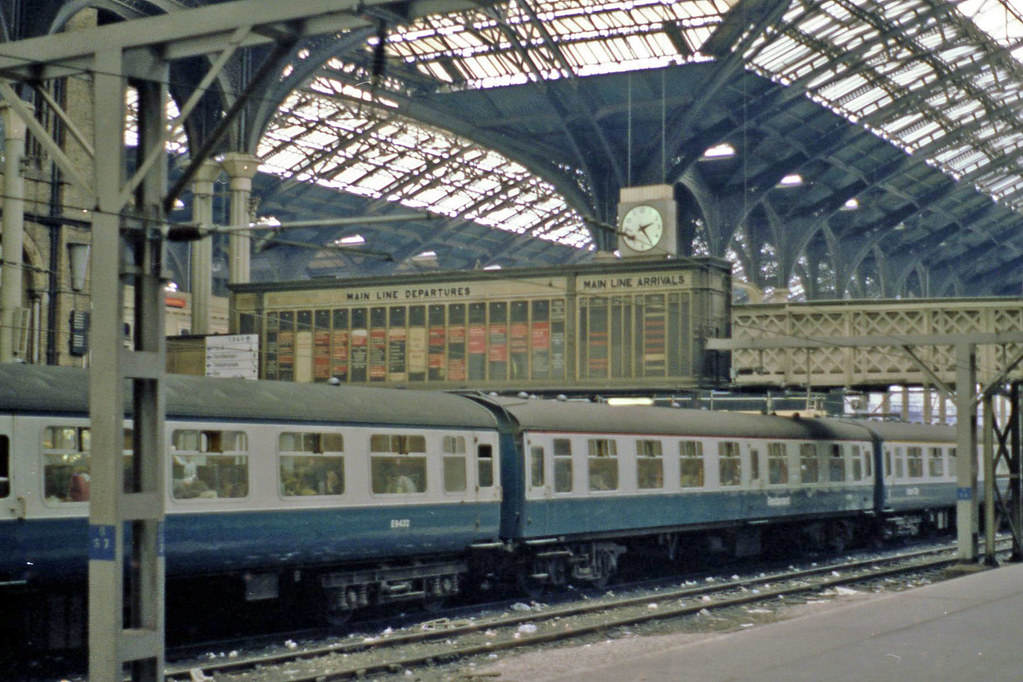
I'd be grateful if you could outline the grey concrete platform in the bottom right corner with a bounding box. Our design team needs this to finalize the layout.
[544,564,1023,682]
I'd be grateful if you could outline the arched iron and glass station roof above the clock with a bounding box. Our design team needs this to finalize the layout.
[36,0,1023,298]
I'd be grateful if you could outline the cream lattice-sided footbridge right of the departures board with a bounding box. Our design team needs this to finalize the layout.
[730,298,1023,388]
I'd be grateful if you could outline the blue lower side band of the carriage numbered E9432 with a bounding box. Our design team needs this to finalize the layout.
[0,502,499,581]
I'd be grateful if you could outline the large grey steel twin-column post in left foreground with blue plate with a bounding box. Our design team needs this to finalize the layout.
[89,49,167,682]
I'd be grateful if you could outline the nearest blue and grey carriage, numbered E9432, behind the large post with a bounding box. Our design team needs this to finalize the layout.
[0,365,501,638]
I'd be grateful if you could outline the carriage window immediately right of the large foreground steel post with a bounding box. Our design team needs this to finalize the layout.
[171,429,249,500]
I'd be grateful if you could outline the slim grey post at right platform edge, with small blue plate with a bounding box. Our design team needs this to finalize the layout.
[955,343,979,562]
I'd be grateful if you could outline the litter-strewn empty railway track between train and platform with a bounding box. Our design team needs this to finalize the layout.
[166,544,1006,682]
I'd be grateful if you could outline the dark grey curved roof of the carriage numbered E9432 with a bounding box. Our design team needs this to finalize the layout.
[0,364,496,428]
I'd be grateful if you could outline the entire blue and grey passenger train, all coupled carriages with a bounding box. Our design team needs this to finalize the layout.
[0,365,955,648]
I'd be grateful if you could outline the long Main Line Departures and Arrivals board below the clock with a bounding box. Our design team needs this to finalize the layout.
[231,259,731,391]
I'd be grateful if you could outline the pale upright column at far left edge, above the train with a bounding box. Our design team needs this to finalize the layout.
[0,106,25,362]
